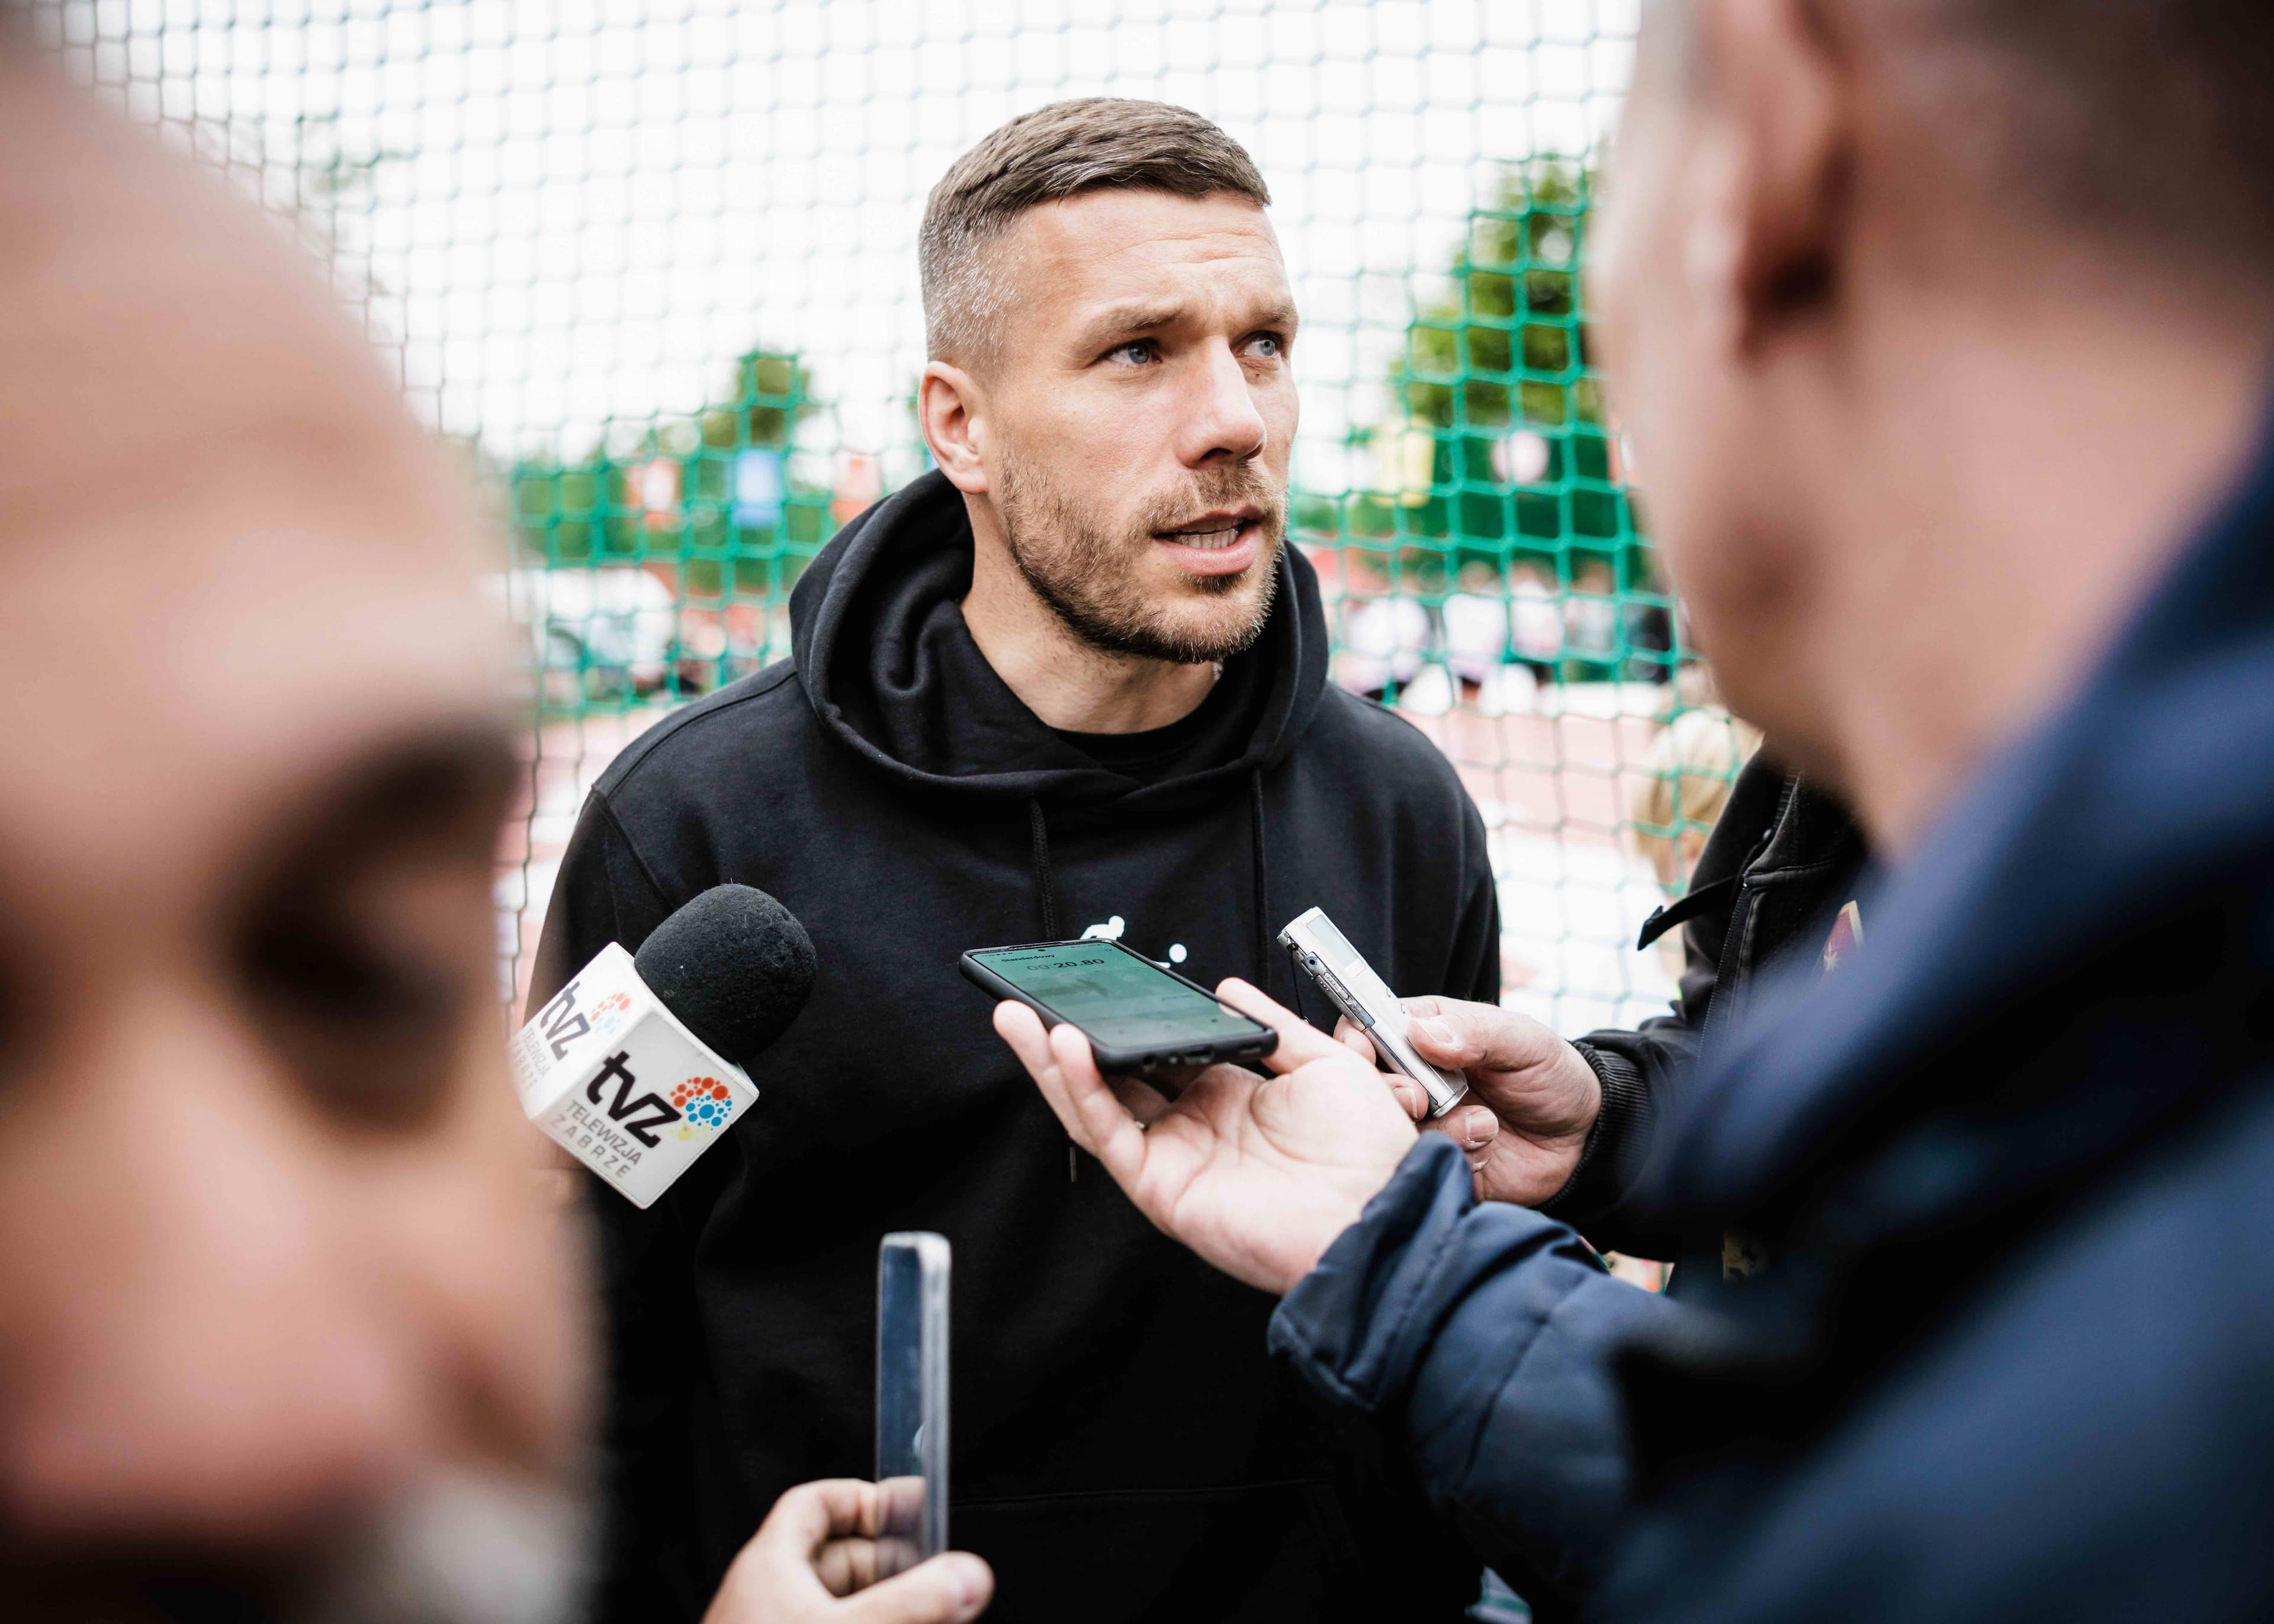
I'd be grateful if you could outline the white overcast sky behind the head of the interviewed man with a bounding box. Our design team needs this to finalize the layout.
[32,0,1635,489]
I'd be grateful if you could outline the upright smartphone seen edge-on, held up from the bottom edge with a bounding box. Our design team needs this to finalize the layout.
[875,1230,948,1578]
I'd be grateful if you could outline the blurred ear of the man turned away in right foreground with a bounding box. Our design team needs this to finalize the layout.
[1694,0,1858,355]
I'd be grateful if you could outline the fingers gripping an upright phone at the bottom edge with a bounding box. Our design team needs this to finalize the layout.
[703,1478,994,1624]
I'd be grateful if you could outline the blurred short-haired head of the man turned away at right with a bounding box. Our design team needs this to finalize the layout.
[1589,0,2274,851]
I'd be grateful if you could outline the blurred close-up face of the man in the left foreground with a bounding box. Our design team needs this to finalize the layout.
[0,38,580,1619]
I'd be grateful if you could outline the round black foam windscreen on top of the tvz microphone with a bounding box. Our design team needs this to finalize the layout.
[632,885,817,1067]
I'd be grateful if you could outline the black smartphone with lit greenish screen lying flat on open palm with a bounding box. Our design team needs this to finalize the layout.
[962,941,1278,1076]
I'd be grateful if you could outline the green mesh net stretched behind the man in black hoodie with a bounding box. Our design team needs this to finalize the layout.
[23,0,1749,1033]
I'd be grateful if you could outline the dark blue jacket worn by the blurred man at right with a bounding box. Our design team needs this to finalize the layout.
[1271,420,2274,1624]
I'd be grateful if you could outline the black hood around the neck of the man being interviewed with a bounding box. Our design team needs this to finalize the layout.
[789,468,1328,808]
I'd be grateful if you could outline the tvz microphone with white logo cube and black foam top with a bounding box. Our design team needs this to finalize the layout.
[512,885,817,1208]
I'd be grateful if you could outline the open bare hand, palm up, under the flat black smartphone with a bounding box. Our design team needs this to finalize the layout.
[996,980,1414,1292]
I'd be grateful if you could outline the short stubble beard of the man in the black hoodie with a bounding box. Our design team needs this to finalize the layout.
[998,462,1287,664]
